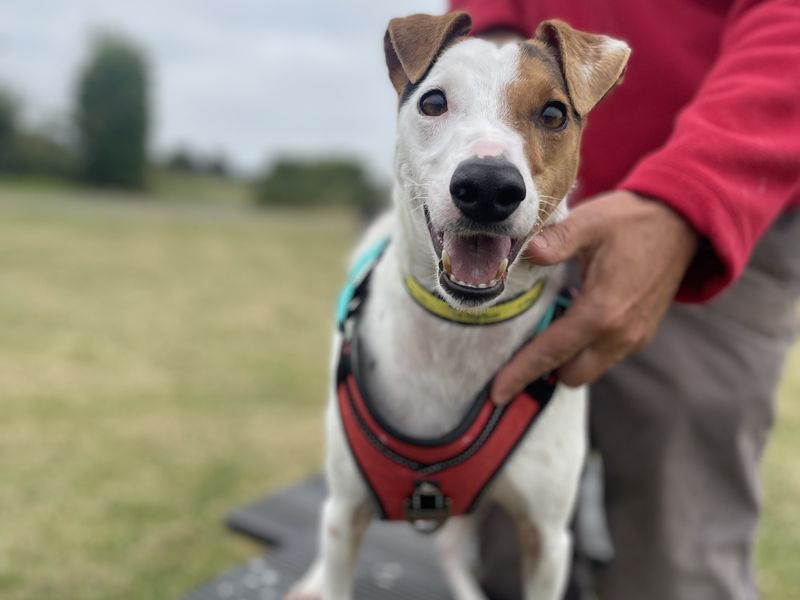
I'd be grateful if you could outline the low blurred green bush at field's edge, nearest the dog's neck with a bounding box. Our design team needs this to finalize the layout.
[256,159,385,216]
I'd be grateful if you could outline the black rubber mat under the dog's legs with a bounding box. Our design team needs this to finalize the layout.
[184,477,452,600]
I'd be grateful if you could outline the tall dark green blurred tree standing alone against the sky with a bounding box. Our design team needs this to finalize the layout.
[77,34,149,188]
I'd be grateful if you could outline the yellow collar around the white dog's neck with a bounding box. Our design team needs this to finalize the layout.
[405,275,545,325]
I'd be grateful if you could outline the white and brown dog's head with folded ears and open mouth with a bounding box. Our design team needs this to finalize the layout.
[384,13,630,310]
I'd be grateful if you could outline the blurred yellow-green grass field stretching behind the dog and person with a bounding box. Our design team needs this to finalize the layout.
[0,182,800,600]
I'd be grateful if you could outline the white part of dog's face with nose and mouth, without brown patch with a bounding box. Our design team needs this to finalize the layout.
[397,39,552,307]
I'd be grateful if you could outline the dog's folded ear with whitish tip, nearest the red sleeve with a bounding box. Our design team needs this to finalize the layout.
[535,19,631,116]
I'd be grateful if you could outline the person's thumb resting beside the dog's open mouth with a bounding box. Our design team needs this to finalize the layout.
[523,206,597,265]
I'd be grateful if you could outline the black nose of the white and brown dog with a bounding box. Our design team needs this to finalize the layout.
[450,156,525,223]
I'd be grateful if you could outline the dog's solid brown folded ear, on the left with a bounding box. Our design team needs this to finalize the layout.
[383,12,472,94]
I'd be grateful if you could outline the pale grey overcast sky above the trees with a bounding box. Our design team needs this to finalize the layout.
[0,0,445,174]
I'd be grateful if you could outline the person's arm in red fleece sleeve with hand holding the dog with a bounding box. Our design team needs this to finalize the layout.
[492,0,800,403]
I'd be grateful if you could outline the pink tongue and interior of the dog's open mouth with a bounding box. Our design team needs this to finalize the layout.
[443,233,511,285]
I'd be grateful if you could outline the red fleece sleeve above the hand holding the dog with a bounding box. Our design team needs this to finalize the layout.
[619,0,800,302]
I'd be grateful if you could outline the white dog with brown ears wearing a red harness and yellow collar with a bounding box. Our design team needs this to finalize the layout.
[287,13,630,600]
